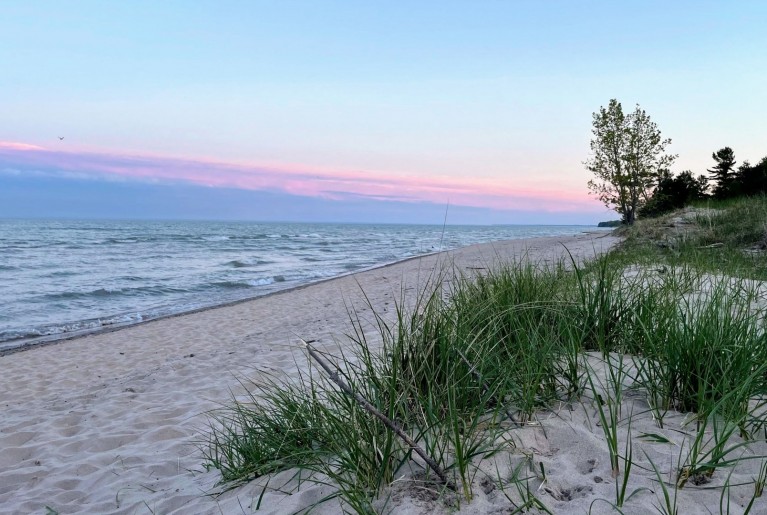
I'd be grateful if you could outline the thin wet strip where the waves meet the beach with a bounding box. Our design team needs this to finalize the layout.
[0,229,612,357]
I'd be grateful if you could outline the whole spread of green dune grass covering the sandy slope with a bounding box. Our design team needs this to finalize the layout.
[203,198,767,513]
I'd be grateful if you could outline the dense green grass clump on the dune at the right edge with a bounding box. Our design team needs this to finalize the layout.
[634,270,767,420]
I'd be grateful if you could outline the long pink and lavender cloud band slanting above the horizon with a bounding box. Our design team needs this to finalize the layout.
[0,142,600,212]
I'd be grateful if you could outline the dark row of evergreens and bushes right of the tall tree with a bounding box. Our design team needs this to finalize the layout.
[640,147,767,217]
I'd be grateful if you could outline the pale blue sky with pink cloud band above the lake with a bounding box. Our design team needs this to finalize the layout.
[0,0,767,224]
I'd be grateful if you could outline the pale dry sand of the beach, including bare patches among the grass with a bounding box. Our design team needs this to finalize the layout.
[6,233,765,514]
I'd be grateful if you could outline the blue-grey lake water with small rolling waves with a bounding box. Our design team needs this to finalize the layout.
[0,220,595,350]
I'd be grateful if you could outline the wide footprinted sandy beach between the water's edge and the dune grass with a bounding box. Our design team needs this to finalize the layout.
[0,232,619,515]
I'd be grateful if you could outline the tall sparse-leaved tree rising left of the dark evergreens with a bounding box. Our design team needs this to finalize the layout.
[584,99,676,224]
